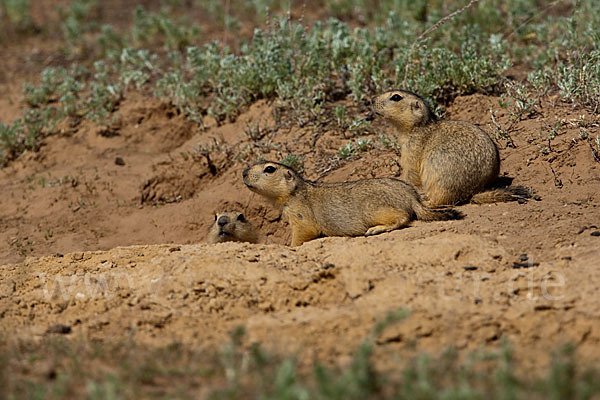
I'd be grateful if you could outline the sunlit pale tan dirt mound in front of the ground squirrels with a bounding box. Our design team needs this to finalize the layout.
[0,231,600,372]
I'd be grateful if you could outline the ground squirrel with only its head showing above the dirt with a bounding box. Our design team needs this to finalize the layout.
[206,211,258,243]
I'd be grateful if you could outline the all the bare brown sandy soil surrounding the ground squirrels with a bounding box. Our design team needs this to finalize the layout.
[0,0,600,376]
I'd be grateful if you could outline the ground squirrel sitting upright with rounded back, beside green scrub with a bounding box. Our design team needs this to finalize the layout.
[371,90,529,207]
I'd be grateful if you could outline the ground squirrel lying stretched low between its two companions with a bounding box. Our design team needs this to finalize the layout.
[242,162,462,246]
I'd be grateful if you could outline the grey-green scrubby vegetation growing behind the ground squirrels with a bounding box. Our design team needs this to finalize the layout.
[8,0,600,163]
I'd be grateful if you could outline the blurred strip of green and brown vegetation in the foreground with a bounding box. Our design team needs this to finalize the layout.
[0,318,600,400]
